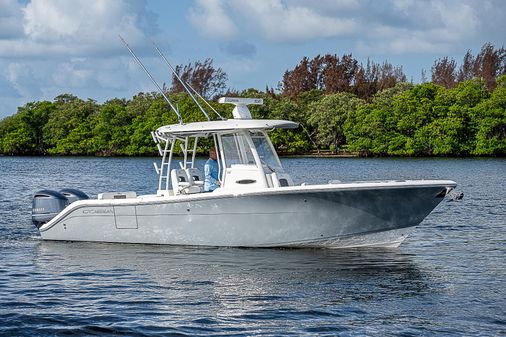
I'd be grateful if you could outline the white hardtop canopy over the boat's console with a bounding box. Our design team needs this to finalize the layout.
[156,119,299,137]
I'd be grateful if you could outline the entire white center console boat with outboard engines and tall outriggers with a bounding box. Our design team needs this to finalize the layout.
[32,41,456,248]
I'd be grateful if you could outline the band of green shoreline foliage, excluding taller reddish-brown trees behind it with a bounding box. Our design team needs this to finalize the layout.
[0,75,506,156]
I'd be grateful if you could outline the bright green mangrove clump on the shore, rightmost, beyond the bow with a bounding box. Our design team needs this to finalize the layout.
[344,77,506,156]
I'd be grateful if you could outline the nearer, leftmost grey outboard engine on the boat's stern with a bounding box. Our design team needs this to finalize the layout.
[32,190,69,228]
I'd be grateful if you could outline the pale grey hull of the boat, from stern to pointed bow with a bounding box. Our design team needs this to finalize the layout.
[39,183,454,248]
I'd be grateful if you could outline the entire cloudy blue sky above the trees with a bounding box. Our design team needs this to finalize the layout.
[0,0,506,119]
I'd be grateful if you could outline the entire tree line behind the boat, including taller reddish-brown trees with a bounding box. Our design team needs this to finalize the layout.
[0,44,506,156]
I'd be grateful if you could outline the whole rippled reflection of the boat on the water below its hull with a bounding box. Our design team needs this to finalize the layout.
[31,242,430,322]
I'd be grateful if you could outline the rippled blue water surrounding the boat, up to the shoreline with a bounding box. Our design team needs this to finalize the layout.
[0,157,506,336]
